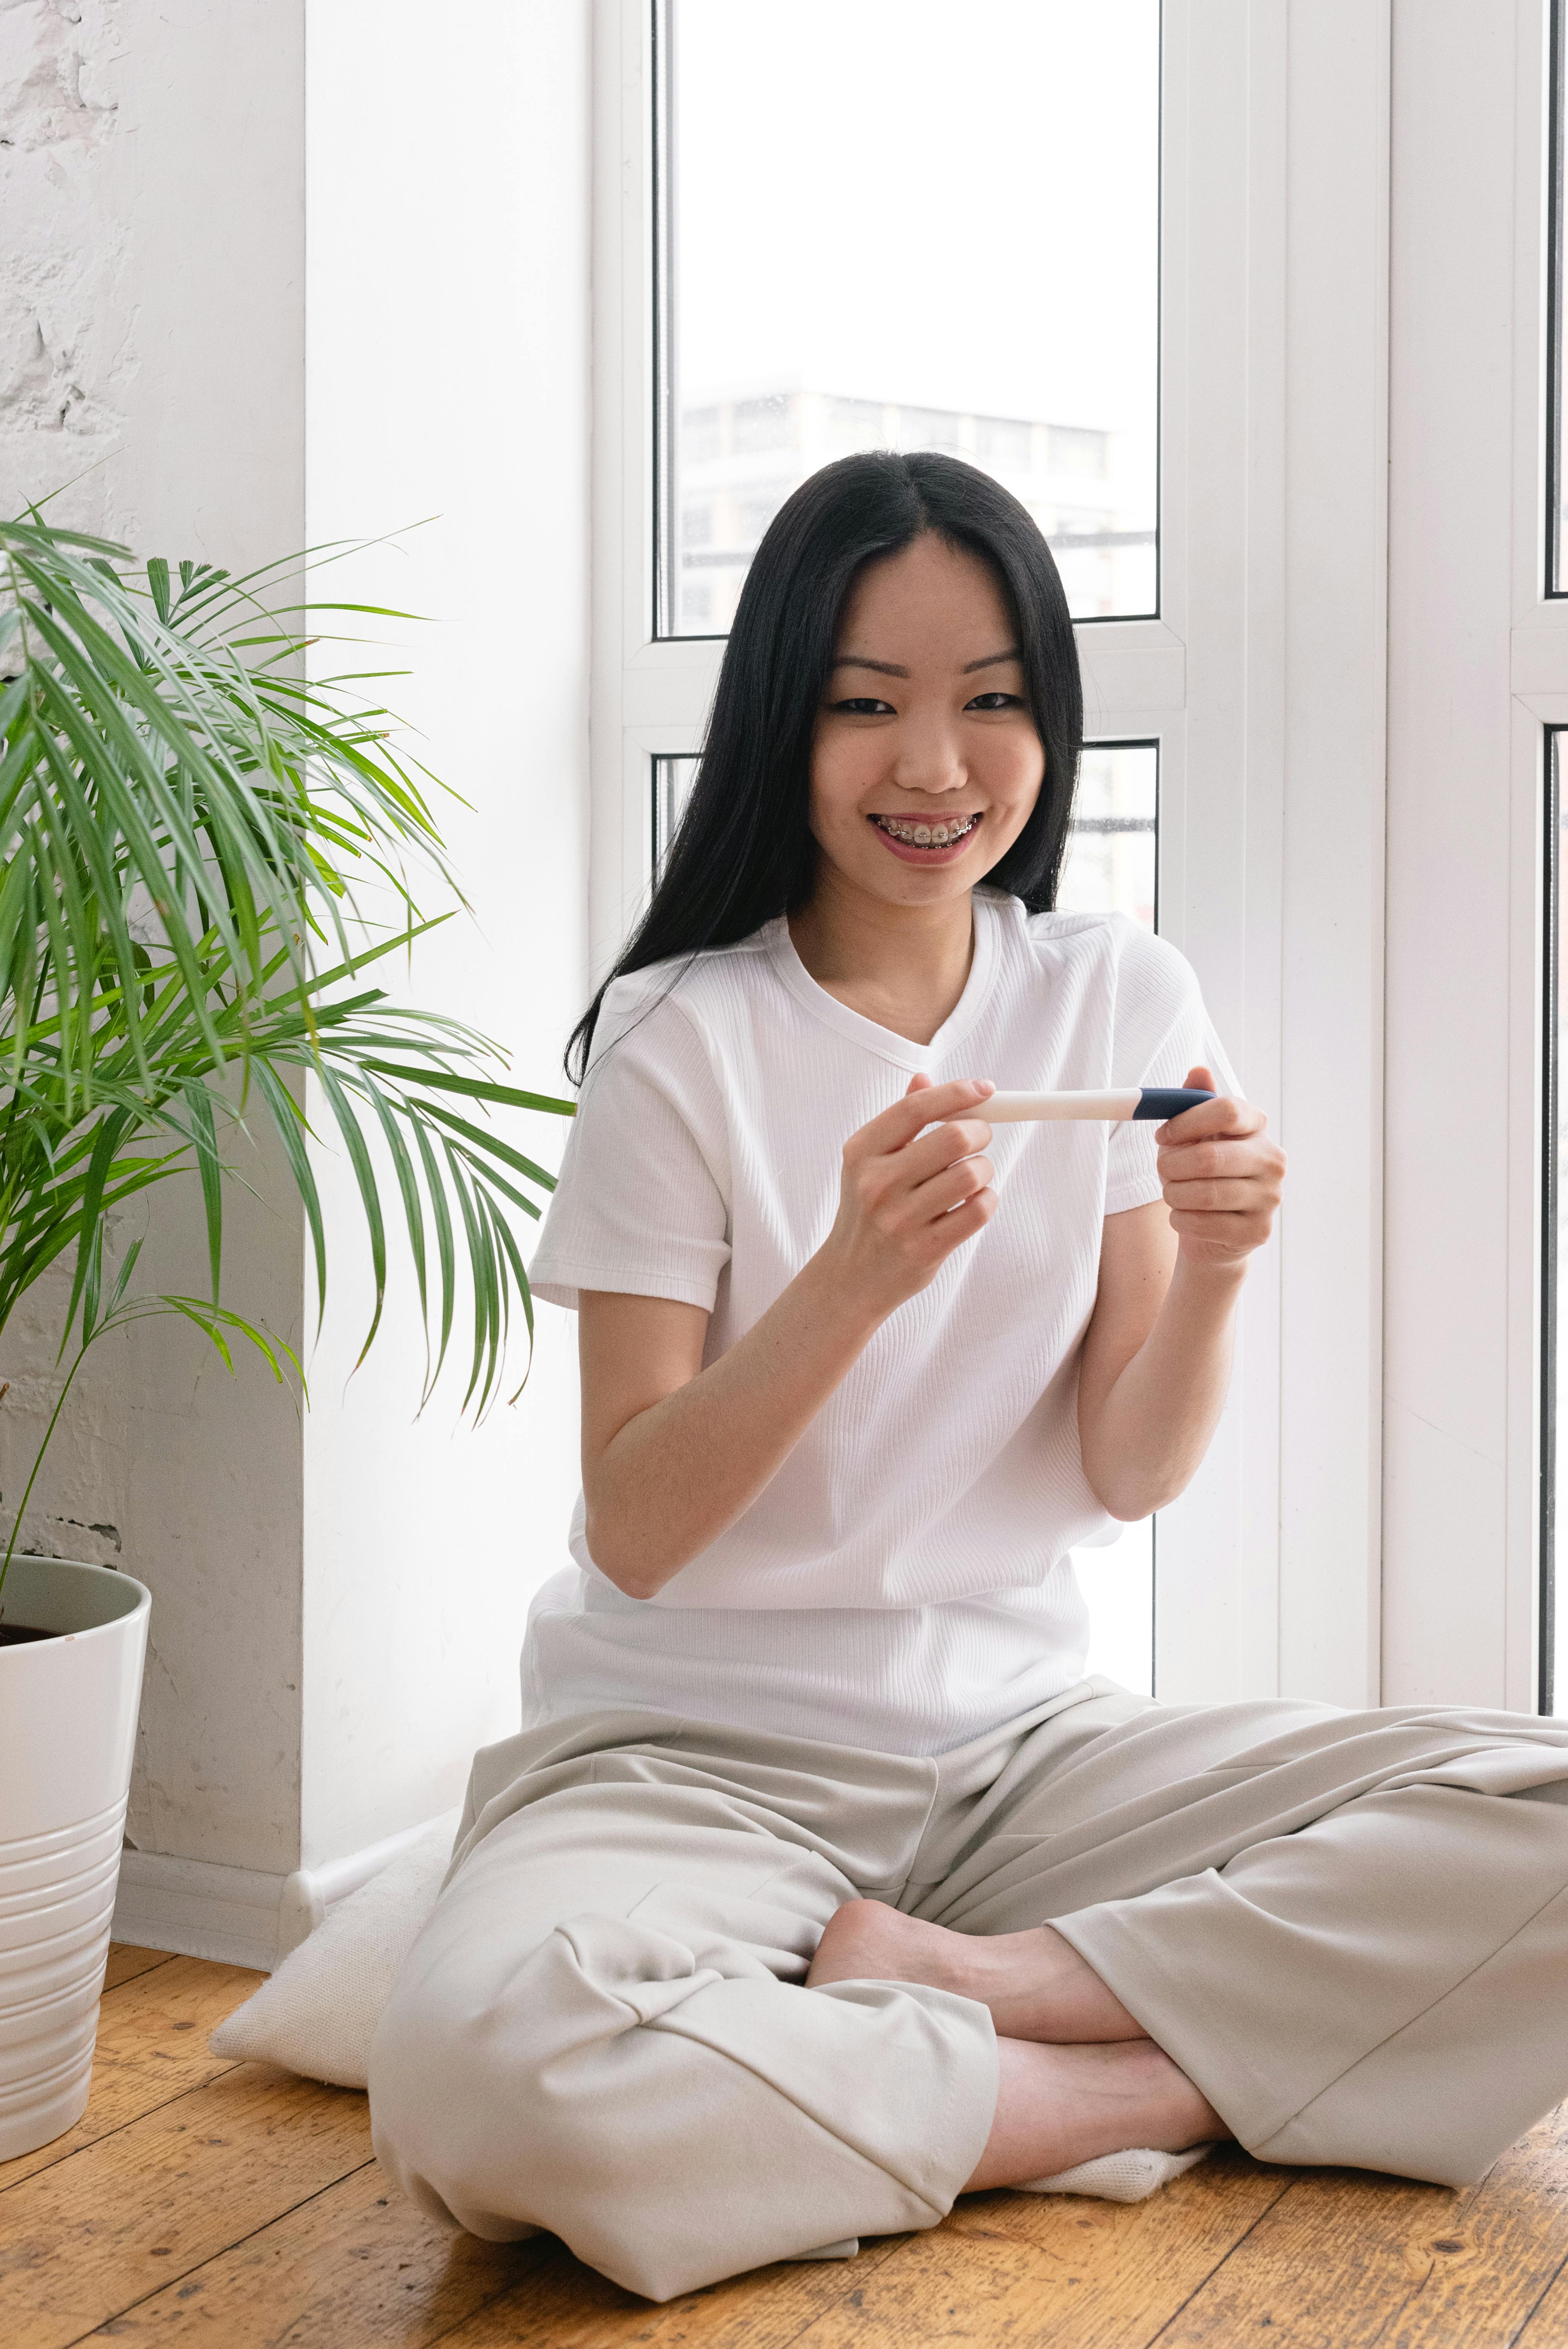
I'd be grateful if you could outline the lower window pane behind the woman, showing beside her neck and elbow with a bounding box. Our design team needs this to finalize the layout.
[650,742,1160,1696]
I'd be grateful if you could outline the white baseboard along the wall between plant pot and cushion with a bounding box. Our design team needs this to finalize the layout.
[115,1811,458,1973]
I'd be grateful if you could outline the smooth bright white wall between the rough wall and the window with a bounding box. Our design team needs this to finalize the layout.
[303,0,589,1865]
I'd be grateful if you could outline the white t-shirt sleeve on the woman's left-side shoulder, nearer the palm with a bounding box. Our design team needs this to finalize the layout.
[528,975,730,1313]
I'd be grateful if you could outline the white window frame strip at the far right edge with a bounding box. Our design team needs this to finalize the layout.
[1385,0,1568,1710]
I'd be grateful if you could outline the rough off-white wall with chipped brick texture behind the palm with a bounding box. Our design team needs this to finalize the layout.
[0,0,305,1870]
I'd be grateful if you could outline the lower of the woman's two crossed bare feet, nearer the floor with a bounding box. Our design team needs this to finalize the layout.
[962,2039,1230,2194]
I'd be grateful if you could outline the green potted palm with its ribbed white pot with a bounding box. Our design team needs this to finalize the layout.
[0,512,570,2159]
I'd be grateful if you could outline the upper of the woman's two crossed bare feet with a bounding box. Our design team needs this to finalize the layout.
[805,1900,1150,2048]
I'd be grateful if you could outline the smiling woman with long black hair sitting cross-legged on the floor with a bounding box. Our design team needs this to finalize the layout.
[369,453,1568,2300]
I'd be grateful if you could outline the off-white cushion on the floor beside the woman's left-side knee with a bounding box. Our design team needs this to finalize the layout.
[207,1818,453,2088]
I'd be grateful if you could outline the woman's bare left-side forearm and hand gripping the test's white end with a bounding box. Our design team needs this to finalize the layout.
[577,1076,995,1600]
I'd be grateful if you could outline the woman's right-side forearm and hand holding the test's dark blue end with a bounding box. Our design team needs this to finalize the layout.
[1077,1069,1284,1520]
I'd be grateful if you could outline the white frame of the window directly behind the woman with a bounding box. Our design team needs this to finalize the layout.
[589,0,1390,1703]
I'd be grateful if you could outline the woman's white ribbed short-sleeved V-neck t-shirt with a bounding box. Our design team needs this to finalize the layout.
[524,890,1230,1755]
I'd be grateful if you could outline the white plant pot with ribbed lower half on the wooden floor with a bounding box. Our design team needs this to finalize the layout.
[0,1558,153,2161]
